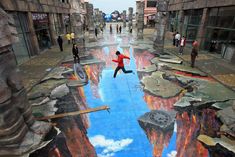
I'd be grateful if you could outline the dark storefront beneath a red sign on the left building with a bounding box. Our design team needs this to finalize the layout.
[32,13,51,50]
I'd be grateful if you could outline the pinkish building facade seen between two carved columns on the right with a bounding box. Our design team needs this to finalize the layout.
[144,0,157,27]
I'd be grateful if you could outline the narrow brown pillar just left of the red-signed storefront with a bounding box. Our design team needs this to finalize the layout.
[27,12,40,56]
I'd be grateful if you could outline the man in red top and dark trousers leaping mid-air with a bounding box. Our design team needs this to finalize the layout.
[112,51,133,78]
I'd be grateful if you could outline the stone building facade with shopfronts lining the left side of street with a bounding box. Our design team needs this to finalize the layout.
[0,0,86,64]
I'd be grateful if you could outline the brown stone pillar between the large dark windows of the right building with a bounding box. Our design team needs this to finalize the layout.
[197,8,209,48]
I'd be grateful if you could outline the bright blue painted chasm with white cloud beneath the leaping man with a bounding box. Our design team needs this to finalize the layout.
[84,48,152,157]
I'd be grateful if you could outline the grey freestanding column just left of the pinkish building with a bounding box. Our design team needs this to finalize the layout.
[136,1,144,39]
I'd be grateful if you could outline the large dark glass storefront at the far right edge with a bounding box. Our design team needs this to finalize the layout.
[204,6,235,56]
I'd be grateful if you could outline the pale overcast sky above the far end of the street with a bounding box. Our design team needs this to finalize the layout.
[89,0,136,14]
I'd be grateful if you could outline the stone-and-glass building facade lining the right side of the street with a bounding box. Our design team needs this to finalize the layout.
[168,0,235,56]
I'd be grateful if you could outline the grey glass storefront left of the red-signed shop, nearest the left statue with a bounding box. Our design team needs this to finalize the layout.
[9,12,34,64]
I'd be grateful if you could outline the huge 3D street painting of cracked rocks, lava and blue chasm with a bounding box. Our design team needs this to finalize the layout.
[29,30,235,157]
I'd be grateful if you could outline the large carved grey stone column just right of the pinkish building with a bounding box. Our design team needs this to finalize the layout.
[154,0,168,52]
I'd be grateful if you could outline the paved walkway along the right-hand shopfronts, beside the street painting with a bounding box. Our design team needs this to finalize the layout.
[165,41,235,90]
